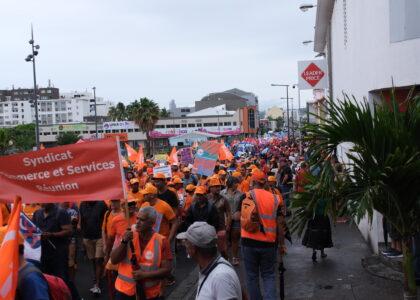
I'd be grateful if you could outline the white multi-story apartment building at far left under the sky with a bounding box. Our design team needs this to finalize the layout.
[0,88,112,127]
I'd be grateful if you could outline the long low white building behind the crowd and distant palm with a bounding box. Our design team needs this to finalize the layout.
[40,105,259,149]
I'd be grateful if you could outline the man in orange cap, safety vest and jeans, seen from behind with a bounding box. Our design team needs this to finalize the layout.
[239,168,285,300]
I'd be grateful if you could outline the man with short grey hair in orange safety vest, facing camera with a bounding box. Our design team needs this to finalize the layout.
[111,206,172,299]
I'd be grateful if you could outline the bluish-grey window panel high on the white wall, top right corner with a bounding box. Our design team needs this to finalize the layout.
[389,0,420,43]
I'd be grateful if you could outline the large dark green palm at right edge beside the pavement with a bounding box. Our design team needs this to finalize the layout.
[292,91,420,299]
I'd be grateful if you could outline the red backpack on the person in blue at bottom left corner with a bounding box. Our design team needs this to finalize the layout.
[18,266,72,300]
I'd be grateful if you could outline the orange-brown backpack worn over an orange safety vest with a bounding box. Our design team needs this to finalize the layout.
[241,190,261,233]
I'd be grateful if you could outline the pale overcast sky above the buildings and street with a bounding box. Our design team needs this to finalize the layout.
[0,0,315,108]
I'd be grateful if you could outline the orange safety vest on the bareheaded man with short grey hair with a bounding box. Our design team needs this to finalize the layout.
[115,230,164,299]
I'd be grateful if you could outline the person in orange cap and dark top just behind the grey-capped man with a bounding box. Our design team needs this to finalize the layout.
[183,185,220,231]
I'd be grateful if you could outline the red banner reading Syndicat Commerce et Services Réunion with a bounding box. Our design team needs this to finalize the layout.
[0,139,124,203]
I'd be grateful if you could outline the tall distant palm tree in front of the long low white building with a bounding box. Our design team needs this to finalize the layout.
[127,98,160,154]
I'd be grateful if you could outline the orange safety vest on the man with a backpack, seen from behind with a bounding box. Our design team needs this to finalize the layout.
[241,189,280,243]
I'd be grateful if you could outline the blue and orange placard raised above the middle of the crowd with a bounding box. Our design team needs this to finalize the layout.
[193,142,220,176]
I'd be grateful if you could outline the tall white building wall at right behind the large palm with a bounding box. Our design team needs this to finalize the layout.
[314,0,420,252]
